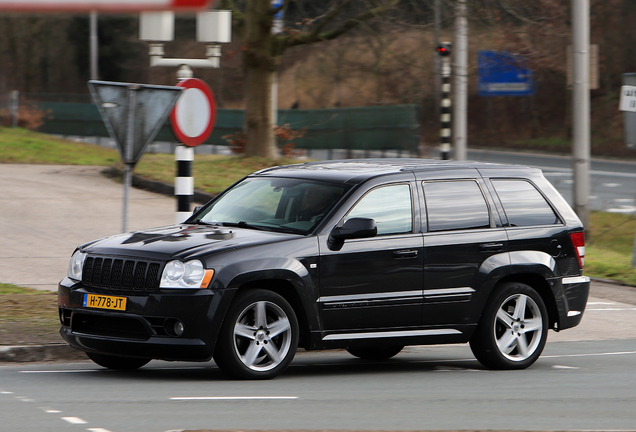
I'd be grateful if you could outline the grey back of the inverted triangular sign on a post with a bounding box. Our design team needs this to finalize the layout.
[88,80,183,165]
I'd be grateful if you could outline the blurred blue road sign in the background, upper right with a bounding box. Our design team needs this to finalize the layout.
[478,51,535,96]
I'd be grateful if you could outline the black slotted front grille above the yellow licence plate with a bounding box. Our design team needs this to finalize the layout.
[82,256,161,291]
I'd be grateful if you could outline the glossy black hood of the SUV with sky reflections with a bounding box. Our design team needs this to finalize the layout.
[82,224,299,260]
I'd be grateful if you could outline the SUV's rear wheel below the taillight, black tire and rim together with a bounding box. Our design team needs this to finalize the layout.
[470,282,548,369]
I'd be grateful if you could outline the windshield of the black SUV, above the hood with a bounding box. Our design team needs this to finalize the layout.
[192,177,348,234]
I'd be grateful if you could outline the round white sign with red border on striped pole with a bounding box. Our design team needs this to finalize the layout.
[170,78,216,147]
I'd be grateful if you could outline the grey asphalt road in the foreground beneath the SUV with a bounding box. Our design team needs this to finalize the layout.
[0,339,636,432]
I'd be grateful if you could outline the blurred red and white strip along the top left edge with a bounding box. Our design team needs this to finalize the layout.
[0,0,212,12]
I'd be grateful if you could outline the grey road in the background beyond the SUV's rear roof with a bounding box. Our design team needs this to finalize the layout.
[468,150,636,213]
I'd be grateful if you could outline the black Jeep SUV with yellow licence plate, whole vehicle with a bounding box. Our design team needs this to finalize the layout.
[59,159,589,379]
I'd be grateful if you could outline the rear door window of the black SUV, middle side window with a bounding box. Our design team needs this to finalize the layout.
[424,180,490,231]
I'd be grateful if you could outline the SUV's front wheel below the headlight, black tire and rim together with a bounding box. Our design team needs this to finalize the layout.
[214,289,298,380]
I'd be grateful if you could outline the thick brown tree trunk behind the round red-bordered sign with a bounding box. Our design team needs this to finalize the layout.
[243,0,278,159]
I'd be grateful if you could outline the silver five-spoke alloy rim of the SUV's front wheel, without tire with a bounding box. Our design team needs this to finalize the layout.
[234,301,292,372]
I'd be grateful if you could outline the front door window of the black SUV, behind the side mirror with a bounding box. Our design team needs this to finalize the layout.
[345,184,413,235]
